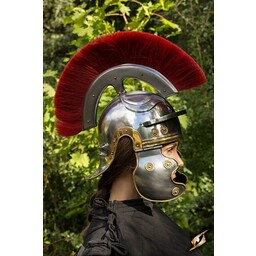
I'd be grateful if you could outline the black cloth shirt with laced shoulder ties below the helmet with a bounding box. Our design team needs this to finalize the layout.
[77,198,202,256]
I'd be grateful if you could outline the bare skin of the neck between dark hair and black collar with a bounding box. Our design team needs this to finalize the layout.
[109,172,141,201]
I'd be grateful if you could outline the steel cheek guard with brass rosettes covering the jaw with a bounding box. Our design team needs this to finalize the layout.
[133,148,187,202]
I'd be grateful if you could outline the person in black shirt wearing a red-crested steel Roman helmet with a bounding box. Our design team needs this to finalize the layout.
[55,32,206,256]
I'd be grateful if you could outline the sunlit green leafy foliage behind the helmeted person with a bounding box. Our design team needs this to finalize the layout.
[43,0,214,256]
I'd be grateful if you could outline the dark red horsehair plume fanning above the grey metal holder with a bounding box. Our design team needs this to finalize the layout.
[54,31,206,136]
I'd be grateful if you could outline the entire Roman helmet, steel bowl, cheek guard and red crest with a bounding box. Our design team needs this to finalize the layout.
[54,31,206,201]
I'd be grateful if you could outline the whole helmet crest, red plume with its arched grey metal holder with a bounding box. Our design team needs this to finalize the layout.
[54,31,206,137]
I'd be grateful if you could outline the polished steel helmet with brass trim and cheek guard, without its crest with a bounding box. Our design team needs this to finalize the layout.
[93,91,186,201]
